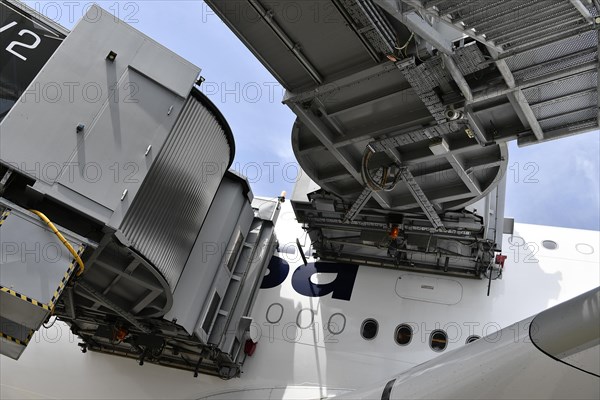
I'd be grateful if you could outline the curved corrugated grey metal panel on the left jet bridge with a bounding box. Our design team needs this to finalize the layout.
[121,92,231,289]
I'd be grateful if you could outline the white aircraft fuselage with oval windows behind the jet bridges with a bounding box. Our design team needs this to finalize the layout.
[0,203,600,399]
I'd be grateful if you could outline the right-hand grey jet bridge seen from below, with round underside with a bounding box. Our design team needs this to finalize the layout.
[207,0,600,277]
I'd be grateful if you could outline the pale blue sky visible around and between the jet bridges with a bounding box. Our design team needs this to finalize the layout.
[26,0,600,230]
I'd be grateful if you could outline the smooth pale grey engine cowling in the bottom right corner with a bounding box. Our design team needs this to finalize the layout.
[340,291,600,400]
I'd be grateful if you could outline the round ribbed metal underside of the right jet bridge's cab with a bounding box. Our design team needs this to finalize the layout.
[292,120,508,213]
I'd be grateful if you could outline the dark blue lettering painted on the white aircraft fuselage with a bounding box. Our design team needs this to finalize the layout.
[260,256,358,301]
